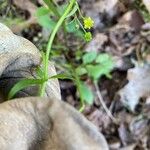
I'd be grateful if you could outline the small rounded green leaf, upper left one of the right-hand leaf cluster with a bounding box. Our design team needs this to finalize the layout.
[82,51,97,64]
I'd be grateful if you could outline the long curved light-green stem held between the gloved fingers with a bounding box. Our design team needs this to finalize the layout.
[40,0,76,96]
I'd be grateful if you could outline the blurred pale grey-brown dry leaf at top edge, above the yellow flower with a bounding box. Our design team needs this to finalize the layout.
[80,0,125,29]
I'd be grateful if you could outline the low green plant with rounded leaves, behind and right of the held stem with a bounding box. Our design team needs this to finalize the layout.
[70,51,114,111]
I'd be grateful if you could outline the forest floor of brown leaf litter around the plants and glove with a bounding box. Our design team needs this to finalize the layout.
[0,0,150,150]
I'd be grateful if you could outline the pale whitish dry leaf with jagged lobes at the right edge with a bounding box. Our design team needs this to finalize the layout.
[119,65,150,111]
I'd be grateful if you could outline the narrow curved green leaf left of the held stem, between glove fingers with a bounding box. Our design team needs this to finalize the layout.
[8,79,44,99]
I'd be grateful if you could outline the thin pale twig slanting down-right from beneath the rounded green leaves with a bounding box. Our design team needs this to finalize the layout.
[94,83,117,123]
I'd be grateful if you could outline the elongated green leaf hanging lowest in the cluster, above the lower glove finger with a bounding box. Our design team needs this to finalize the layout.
[78,81,94,104]
